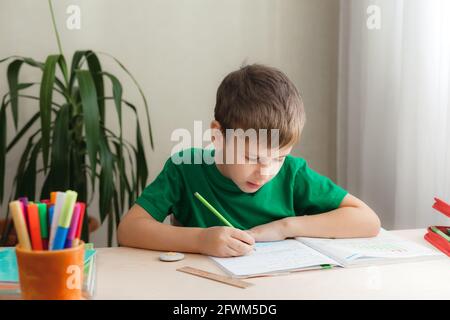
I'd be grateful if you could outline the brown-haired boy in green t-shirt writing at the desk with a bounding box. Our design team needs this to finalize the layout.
[118,65,380,257]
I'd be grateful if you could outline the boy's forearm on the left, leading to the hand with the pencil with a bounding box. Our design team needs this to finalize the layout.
[118,218,202,253]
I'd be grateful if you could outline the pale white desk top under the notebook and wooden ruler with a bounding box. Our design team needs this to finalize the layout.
[95,229,450,299]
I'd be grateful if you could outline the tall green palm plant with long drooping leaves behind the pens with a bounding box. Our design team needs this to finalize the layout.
[0,0,153,245]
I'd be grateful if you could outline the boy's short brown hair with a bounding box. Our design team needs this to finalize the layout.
[214,64,306,148]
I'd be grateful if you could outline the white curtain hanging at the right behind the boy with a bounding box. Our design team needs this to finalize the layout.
[337,0,450,229]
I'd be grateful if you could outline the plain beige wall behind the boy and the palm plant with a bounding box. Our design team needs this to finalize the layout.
[0,0,339,246]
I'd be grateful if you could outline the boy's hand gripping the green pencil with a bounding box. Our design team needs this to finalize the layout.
[199,227,255,257]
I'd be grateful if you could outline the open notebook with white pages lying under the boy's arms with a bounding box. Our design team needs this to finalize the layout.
[211,230,445,278]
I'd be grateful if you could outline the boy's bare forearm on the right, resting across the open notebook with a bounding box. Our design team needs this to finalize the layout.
[281,207,380,238]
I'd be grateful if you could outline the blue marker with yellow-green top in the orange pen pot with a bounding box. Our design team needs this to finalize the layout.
[51,190,77,250]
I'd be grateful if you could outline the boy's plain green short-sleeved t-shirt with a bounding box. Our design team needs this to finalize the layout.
[136,148,347,230]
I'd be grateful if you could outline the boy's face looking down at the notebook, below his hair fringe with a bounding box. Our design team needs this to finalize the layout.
[215,122,292,193]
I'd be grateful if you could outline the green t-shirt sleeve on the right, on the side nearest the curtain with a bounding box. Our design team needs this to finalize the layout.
[294,161,348,215]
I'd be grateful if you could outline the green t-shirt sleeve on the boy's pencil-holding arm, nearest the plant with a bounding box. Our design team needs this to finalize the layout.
[136,158,183,222]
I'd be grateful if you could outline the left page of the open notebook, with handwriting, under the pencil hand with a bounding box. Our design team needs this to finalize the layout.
[211,239,338,277]
